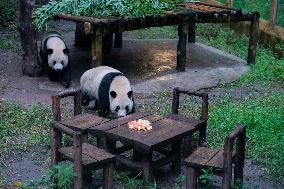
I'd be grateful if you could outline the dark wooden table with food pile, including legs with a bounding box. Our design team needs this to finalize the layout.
[88,113,203,182]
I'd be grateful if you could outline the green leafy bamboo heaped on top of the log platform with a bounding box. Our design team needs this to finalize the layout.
[34,0,180,29]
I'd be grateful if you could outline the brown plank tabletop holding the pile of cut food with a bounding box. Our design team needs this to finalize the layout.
[88,113,203,152]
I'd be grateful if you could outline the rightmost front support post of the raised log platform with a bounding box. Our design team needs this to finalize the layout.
[247,12,259,64]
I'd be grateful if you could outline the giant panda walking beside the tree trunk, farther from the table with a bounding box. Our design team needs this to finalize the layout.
[40,31,71,88]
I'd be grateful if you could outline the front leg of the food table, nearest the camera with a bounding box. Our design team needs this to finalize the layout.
[142,151,154,183]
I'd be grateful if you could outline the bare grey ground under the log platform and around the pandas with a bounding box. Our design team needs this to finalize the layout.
[0,36,249,105]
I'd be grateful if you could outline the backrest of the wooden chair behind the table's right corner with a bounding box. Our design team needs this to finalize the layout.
[172,87,208,120]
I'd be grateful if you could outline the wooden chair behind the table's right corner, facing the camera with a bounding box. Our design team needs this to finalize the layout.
[166,87,208,148]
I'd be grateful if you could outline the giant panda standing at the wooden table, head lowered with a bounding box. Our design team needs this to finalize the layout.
[80,66,135,117]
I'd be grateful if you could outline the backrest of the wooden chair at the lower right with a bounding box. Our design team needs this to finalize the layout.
[223,125,246,169]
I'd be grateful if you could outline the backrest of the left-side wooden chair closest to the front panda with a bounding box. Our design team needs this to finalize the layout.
[51,89,82,121]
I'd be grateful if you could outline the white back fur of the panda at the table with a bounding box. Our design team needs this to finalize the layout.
[80,66,120,99]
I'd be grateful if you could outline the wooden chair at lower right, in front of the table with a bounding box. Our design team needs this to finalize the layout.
[185,125,246,189]
